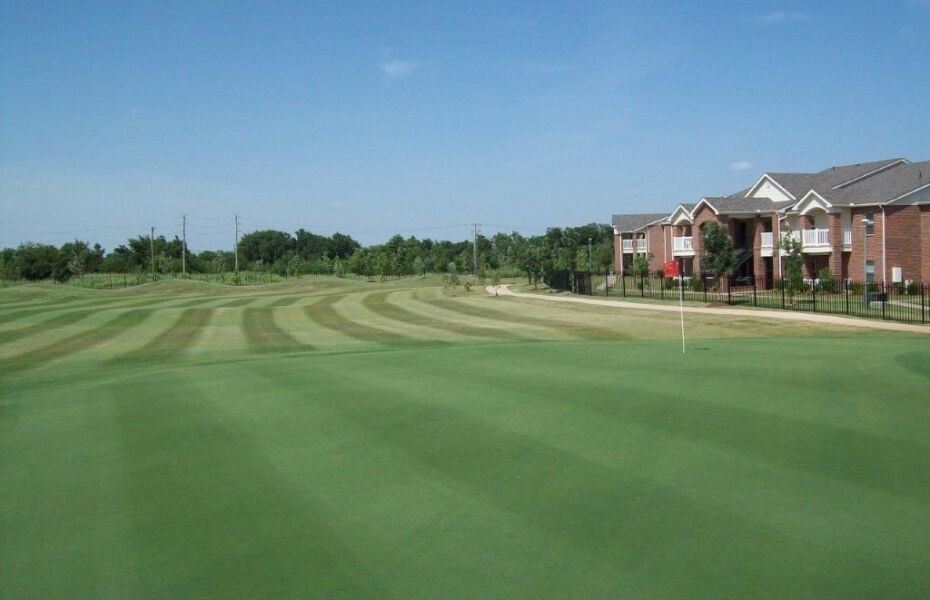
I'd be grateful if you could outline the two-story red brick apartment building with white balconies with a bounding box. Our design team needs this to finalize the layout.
[613,159,930,285]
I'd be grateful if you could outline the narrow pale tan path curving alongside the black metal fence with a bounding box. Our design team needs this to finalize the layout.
[485,285,930,335]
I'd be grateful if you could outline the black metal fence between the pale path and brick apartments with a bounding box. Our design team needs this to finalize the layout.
[544,271,930,323]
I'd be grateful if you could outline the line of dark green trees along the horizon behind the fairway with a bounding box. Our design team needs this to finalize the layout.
[0,223,613,282]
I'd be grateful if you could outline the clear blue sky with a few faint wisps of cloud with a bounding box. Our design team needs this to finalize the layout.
[0,0,930,249]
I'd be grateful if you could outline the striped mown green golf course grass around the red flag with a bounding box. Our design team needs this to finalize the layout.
[0,278,930,599]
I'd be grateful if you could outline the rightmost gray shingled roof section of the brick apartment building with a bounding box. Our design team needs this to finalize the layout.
[817,161,930,206]
